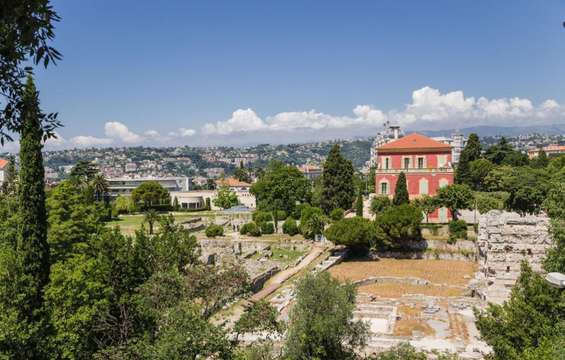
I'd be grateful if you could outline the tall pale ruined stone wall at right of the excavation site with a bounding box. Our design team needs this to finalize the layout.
[476,210,551,303]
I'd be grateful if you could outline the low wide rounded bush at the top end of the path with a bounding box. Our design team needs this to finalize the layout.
[324,216,378,252]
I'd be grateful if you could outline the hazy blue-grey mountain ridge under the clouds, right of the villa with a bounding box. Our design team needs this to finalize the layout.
[417,124,565,137]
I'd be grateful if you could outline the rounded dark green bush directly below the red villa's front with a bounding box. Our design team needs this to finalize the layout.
[375,204,422,247]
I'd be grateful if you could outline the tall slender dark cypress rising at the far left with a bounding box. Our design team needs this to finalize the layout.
[17,77,49,311]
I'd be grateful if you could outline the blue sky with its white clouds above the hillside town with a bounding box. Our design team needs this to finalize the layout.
[28,0,565,147]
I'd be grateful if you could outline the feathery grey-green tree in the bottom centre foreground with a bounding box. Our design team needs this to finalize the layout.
[284,272,368,360]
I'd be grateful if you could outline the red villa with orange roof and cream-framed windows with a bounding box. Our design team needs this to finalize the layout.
[375,133,454,222]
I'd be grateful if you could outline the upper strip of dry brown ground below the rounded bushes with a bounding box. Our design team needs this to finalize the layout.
[329,259,477,291]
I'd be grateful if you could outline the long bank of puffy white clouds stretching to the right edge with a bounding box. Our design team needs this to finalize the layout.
[202,86,565,135]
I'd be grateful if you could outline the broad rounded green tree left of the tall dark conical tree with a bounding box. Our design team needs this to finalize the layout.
[251,161,310,214]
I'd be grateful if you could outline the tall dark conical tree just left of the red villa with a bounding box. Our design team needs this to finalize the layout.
[321,144,355,214]
